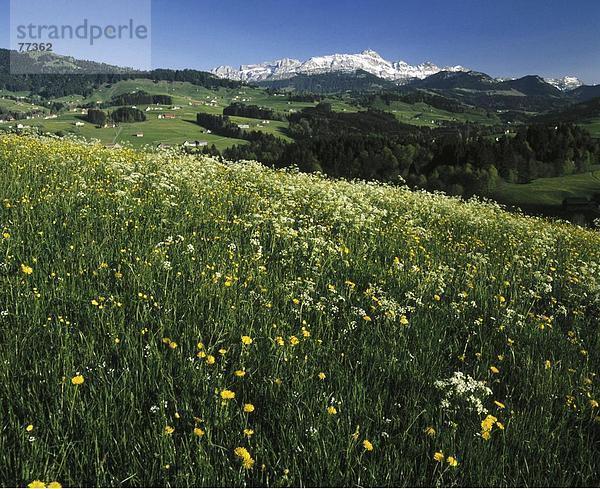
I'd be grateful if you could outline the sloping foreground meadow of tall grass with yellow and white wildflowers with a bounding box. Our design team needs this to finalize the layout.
[0,135,600,487]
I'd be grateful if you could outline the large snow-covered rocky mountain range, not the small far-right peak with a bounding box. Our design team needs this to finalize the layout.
[212,50,469,82]
